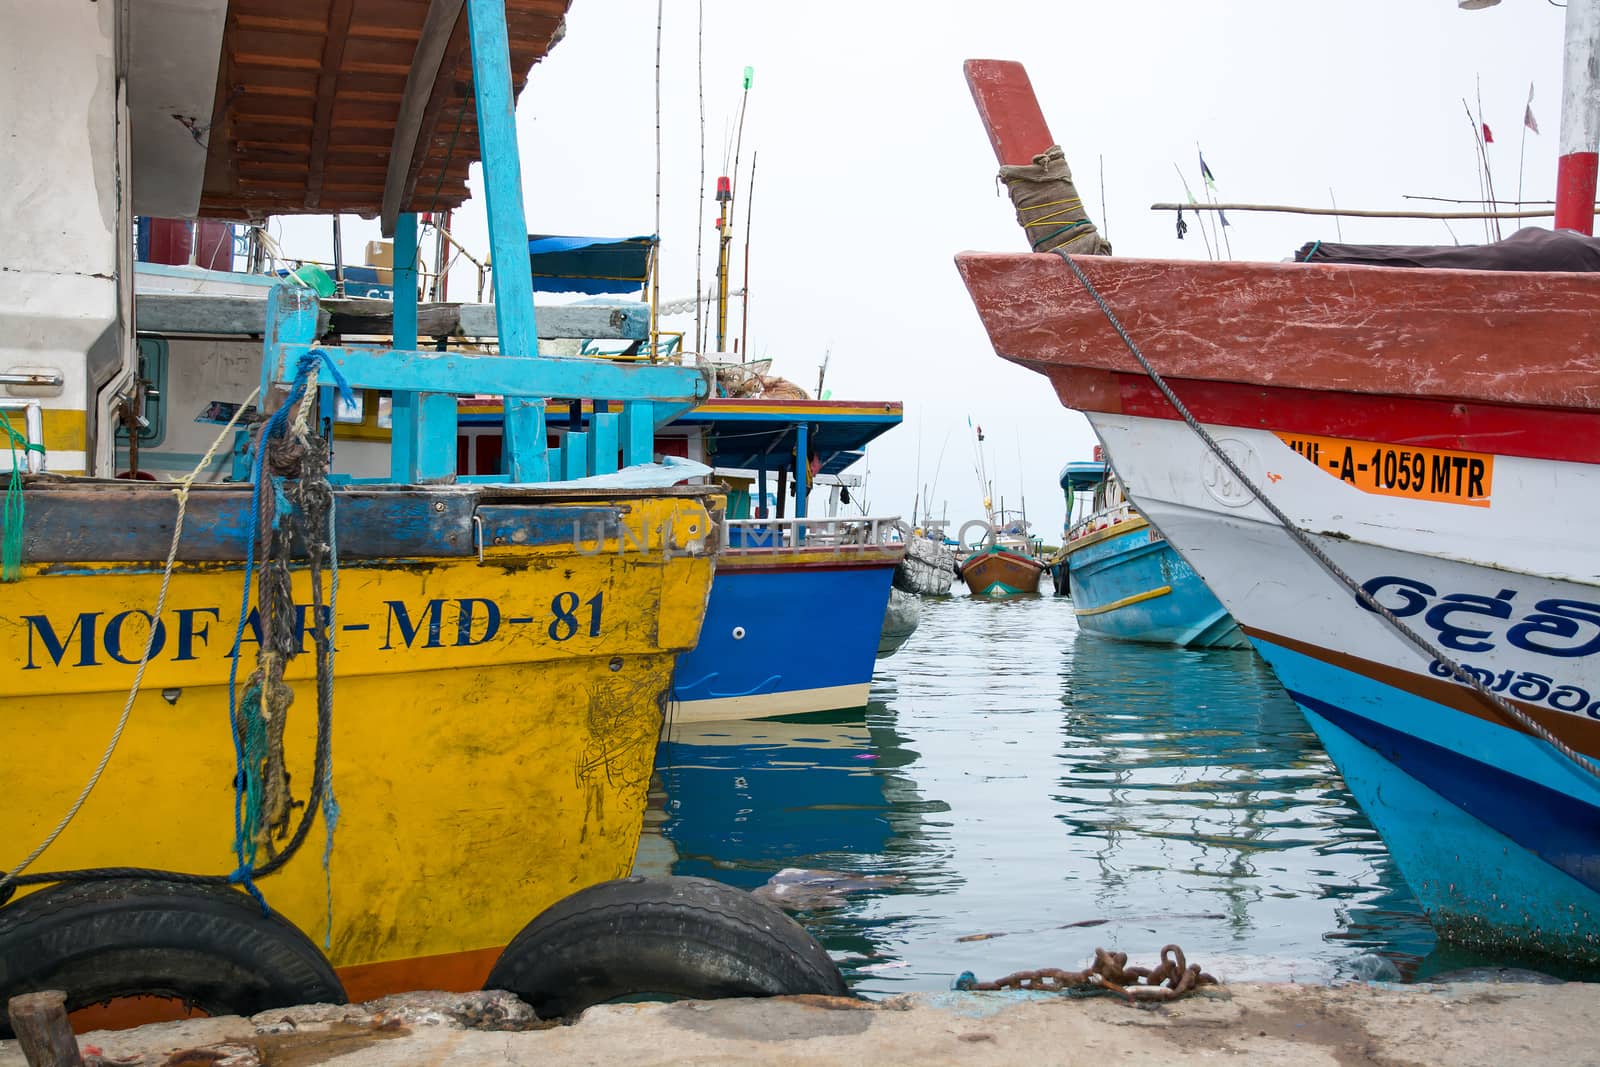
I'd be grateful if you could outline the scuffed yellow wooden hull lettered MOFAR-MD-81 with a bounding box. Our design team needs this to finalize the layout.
[0,485,718,1000]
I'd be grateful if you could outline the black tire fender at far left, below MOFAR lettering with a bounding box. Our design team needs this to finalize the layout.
[0,878,346,1037]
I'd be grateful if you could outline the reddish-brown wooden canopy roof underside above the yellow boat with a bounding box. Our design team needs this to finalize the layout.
[200,0,571,223]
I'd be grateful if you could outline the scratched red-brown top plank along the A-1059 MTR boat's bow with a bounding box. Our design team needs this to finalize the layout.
[957,253,1600,412]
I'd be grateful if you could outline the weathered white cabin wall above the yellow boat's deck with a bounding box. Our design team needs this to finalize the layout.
[0,0,128,474]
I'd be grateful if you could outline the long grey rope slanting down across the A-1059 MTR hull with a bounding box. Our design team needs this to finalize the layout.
[1056,250,1600,777]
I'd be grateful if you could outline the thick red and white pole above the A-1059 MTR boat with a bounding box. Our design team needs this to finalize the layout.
[1555,0,1600,234]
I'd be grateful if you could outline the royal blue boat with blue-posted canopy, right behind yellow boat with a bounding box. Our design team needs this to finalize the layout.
[656,398,906,721]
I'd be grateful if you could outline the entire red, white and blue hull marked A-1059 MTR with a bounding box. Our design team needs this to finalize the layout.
[962,256,1600,961]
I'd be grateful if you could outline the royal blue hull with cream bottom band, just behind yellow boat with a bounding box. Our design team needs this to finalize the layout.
[670,545,906,723]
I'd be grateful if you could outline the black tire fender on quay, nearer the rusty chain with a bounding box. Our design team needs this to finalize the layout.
[485,877,850,1019]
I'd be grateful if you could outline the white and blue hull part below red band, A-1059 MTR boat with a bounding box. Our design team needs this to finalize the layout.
[1090,414,1600,961]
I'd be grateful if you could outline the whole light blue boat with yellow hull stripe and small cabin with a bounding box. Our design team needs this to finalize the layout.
[1053,448,1250,648]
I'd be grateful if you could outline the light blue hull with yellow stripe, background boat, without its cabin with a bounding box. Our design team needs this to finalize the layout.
[1062,517,1250,648]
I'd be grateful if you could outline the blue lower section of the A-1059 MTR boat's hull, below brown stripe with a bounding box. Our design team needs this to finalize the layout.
[1254,635,1600,960]
